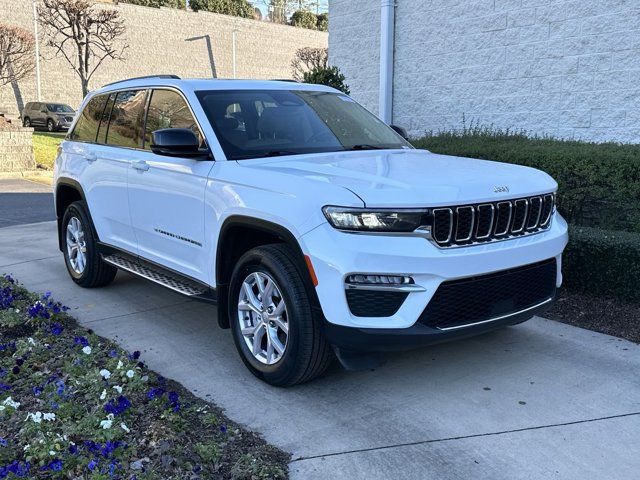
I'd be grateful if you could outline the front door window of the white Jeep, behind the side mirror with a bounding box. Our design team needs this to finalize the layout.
[144,90,204,150]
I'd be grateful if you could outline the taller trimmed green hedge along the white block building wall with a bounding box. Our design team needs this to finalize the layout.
[413,127,640,233]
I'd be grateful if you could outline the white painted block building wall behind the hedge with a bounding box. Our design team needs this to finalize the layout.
[329,0,640,143]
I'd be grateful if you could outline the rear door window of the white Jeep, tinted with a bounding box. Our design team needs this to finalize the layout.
[107,90,147,148]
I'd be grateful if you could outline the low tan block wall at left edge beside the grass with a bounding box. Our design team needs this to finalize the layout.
[0,117,36,172]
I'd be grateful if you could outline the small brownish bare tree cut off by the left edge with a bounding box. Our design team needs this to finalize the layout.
[0,23,36,85]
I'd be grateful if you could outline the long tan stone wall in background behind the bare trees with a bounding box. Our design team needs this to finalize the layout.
[0,0,328,115]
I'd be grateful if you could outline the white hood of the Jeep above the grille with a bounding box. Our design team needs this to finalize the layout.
[240,150,557,207]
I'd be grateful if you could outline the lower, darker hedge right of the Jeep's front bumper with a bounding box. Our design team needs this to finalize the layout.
[562,226,640,302]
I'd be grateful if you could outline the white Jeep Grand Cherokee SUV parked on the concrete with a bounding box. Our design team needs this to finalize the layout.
[55,76,567,385]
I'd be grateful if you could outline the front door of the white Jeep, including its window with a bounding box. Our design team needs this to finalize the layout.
[129,88,214,282]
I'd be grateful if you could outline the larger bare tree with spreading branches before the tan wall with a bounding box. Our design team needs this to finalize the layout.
[38,0,128,95]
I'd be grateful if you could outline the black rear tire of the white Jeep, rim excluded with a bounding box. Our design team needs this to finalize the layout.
[61,201,118,288]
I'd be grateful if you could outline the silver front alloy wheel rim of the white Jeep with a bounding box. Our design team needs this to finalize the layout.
[238,272,289,365]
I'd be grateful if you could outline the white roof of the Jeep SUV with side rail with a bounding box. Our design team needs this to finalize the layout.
[93,76,338,94]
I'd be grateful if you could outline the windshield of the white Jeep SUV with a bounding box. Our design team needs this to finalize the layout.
[197,90,412,160]
